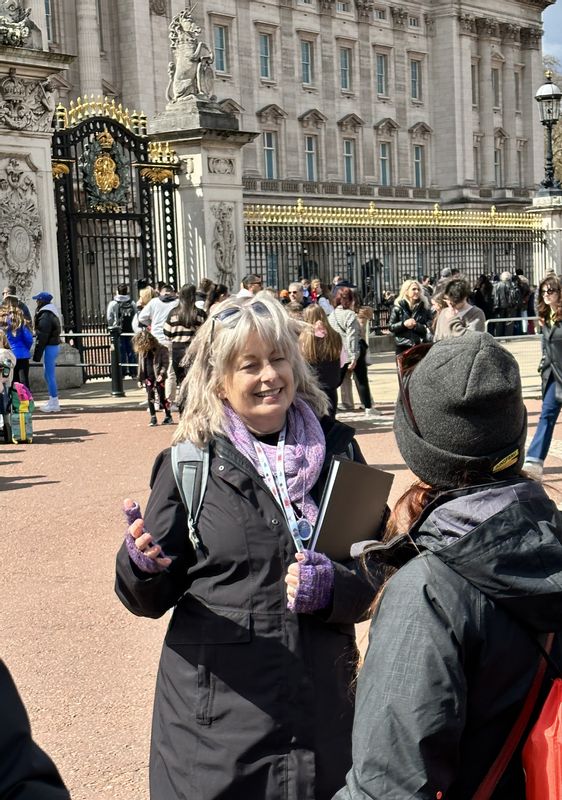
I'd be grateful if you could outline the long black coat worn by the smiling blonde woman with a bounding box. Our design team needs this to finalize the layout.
[116,422,374,800]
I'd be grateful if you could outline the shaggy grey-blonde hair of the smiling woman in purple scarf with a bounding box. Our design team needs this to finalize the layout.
[174,295,328,447]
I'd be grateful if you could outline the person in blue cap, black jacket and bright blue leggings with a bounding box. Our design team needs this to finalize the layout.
[33,292,62,414]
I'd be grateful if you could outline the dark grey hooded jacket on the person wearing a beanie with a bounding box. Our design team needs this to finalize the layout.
[336,479,562,800]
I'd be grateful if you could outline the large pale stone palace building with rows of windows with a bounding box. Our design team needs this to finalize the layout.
[38,0,554,207]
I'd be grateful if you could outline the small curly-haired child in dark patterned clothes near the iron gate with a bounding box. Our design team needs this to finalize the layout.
[133,330,173,428]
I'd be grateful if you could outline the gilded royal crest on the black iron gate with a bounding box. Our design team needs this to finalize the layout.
[80,128,130,212]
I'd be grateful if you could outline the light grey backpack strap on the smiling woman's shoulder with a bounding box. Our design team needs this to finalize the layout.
[172,442,211,548]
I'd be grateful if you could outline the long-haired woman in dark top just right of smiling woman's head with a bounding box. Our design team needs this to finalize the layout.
[300,303,342,418]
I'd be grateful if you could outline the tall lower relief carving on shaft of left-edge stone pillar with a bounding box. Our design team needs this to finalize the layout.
[0,154,43,297]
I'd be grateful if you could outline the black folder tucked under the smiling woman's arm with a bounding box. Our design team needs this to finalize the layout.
[310,457,394,561]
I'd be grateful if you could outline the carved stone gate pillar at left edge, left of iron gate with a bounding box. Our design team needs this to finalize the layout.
[0,47,73,303]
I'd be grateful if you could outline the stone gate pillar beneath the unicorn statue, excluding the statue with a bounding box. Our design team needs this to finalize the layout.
[148,102,258,292]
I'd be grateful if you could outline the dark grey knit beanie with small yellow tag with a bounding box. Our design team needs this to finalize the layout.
[394,331,527,488]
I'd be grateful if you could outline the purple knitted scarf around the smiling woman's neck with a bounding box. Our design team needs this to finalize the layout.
[224,397,326,524]
